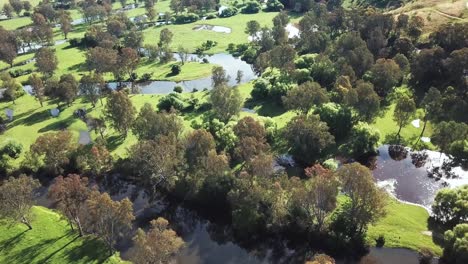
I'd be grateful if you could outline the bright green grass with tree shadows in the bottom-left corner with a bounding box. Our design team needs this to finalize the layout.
[0,206,127,264]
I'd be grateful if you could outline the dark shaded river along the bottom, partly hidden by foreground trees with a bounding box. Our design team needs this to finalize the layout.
[34,168,440,264]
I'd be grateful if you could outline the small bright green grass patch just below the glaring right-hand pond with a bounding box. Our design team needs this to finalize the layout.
[367,198,442,256]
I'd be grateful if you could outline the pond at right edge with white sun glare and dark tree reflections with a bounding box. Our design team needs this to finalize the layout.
[368,145,468,209]
